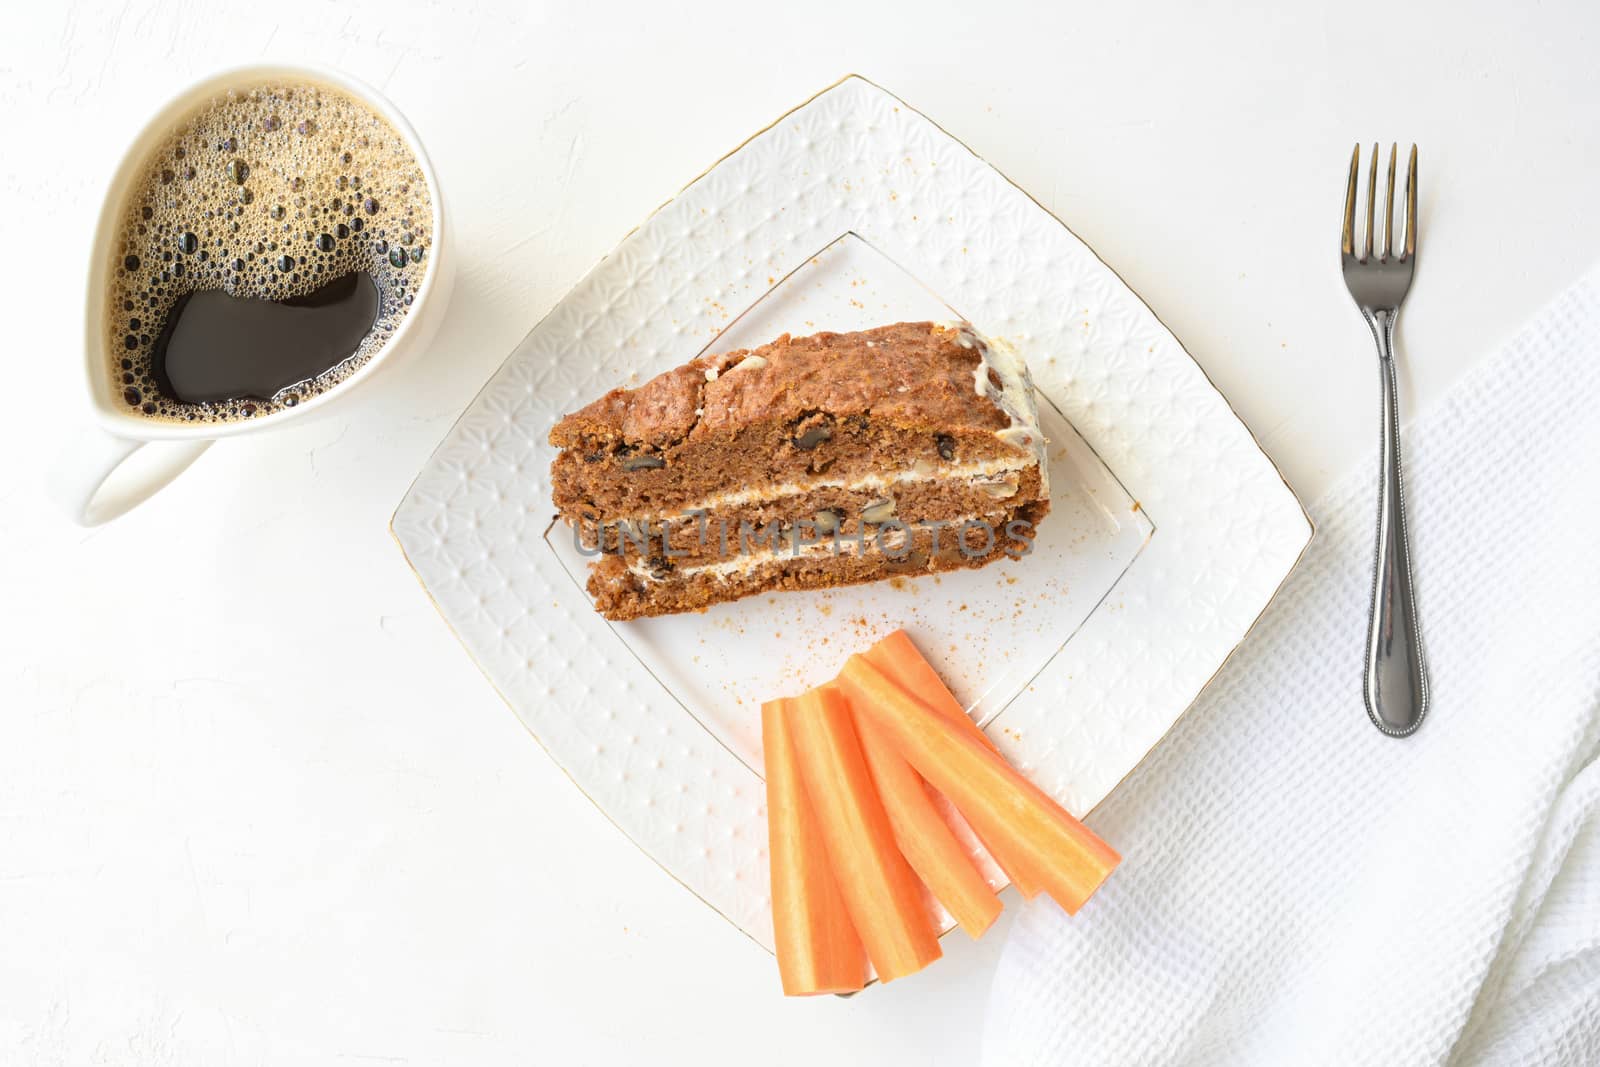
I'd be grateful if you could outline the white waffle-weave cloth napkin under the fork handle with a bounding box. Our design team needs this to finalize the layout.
[984,270,1600,1067]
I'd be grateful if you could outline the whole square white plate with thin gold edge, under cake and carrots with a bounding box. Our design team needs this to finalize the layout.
[394,77,1310,949]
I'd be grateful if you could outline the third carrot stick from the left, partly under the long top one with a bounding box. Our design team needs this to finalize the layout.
[854,715,1000,941]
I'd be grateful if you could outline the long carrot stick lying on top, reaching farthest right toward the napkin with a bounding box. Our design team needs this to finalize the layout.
[838,656,1122,913]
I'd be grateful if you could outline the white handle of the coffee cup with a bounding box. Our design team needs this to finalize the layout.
[50,426,211,526]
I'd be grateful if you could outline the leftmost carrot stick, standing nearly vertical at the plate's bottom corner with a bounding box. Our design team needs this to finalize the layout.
[762,699,867,997]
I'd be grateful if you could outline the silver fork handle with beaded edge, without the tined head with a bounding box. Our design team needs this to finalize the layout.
[1363,310,1427,737]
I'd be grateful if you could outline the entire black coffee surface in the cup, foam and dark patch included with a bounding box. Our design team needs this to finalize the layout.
[107,82,434,421]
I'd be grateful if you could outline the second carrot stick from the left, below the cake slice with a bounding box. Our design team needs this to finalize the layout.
[789,686,941,982]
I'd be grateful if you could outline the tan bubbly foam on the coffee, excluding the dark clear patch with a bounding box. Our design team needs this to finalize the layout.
[106,82,434,422]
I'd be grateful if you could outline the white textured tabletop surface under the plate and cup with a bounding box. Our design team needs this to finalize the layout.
[0,0,1600,1065]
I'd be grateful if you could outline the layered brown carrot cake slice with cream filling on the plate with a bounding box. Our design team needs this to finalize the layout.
[550,322,1050,619]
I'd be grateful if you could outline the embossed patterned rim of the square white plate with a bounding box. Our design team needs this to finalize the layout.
[394,77,1310,947]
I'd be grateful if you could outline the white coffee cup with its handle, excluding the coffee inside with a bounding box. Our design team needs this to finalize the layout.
[50,66,456,526]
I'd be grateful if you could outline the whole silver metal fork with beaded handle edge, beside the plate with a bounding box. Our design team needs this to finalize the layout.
[1339,144,1427,737]
